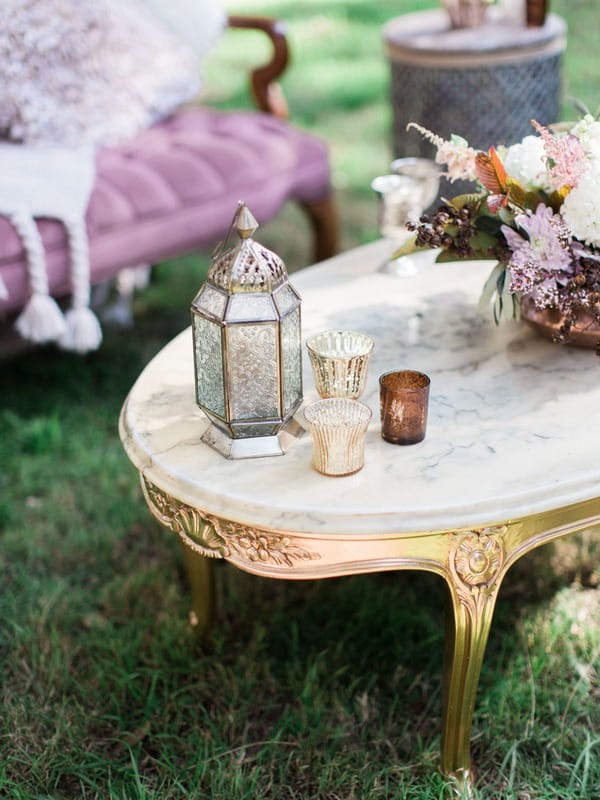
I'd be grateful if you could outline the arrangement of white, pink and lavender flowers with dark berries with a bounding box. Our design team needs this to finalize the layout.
[397,114,600,350]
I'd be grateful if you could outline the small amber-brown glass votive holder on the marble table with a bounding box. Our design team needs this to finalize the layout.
[379,370,430,444]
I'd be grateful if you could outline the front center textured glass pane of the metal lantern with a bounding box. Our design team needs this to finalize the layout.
[227,323,279,420]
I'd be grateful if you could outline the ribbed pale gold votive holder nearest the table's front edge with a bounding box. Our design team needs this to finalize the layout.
[304,397,372,477]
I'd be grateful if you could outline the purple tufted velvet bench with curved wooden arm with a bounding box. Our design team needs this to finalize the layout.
[0,17,337,350]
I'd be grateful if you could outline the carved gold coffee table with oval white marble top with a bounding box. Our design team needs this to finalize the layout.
[120,242,600,797]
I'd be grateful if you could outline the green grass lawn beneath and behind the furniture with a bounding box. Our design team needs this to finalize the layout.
[0,0,600,800]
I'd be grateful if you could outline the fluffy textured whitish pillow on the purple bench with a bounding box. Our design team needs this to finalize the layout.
[0,0,223,146]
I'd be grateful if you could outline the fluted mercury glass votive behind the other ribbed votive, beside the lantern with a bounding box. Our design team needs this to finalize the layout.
[306,331,374,400]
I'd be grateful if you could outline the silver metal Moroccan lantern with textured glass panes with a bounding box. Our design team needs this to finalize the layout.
[191,203,303,458]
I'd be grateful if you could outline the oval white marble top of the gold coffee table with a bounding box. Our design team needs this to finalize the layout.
[121,241,600,535]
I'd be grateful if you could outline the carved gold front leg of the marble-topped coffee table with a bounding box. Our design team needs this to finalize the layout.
[441,532,504,800]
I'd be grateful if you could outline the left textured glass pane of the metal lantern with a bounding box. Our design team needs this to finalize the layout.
[192,314,225,417]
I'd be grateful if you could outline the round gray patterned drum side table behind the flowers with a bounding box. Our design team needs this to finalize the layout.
[383,10,567,157]
